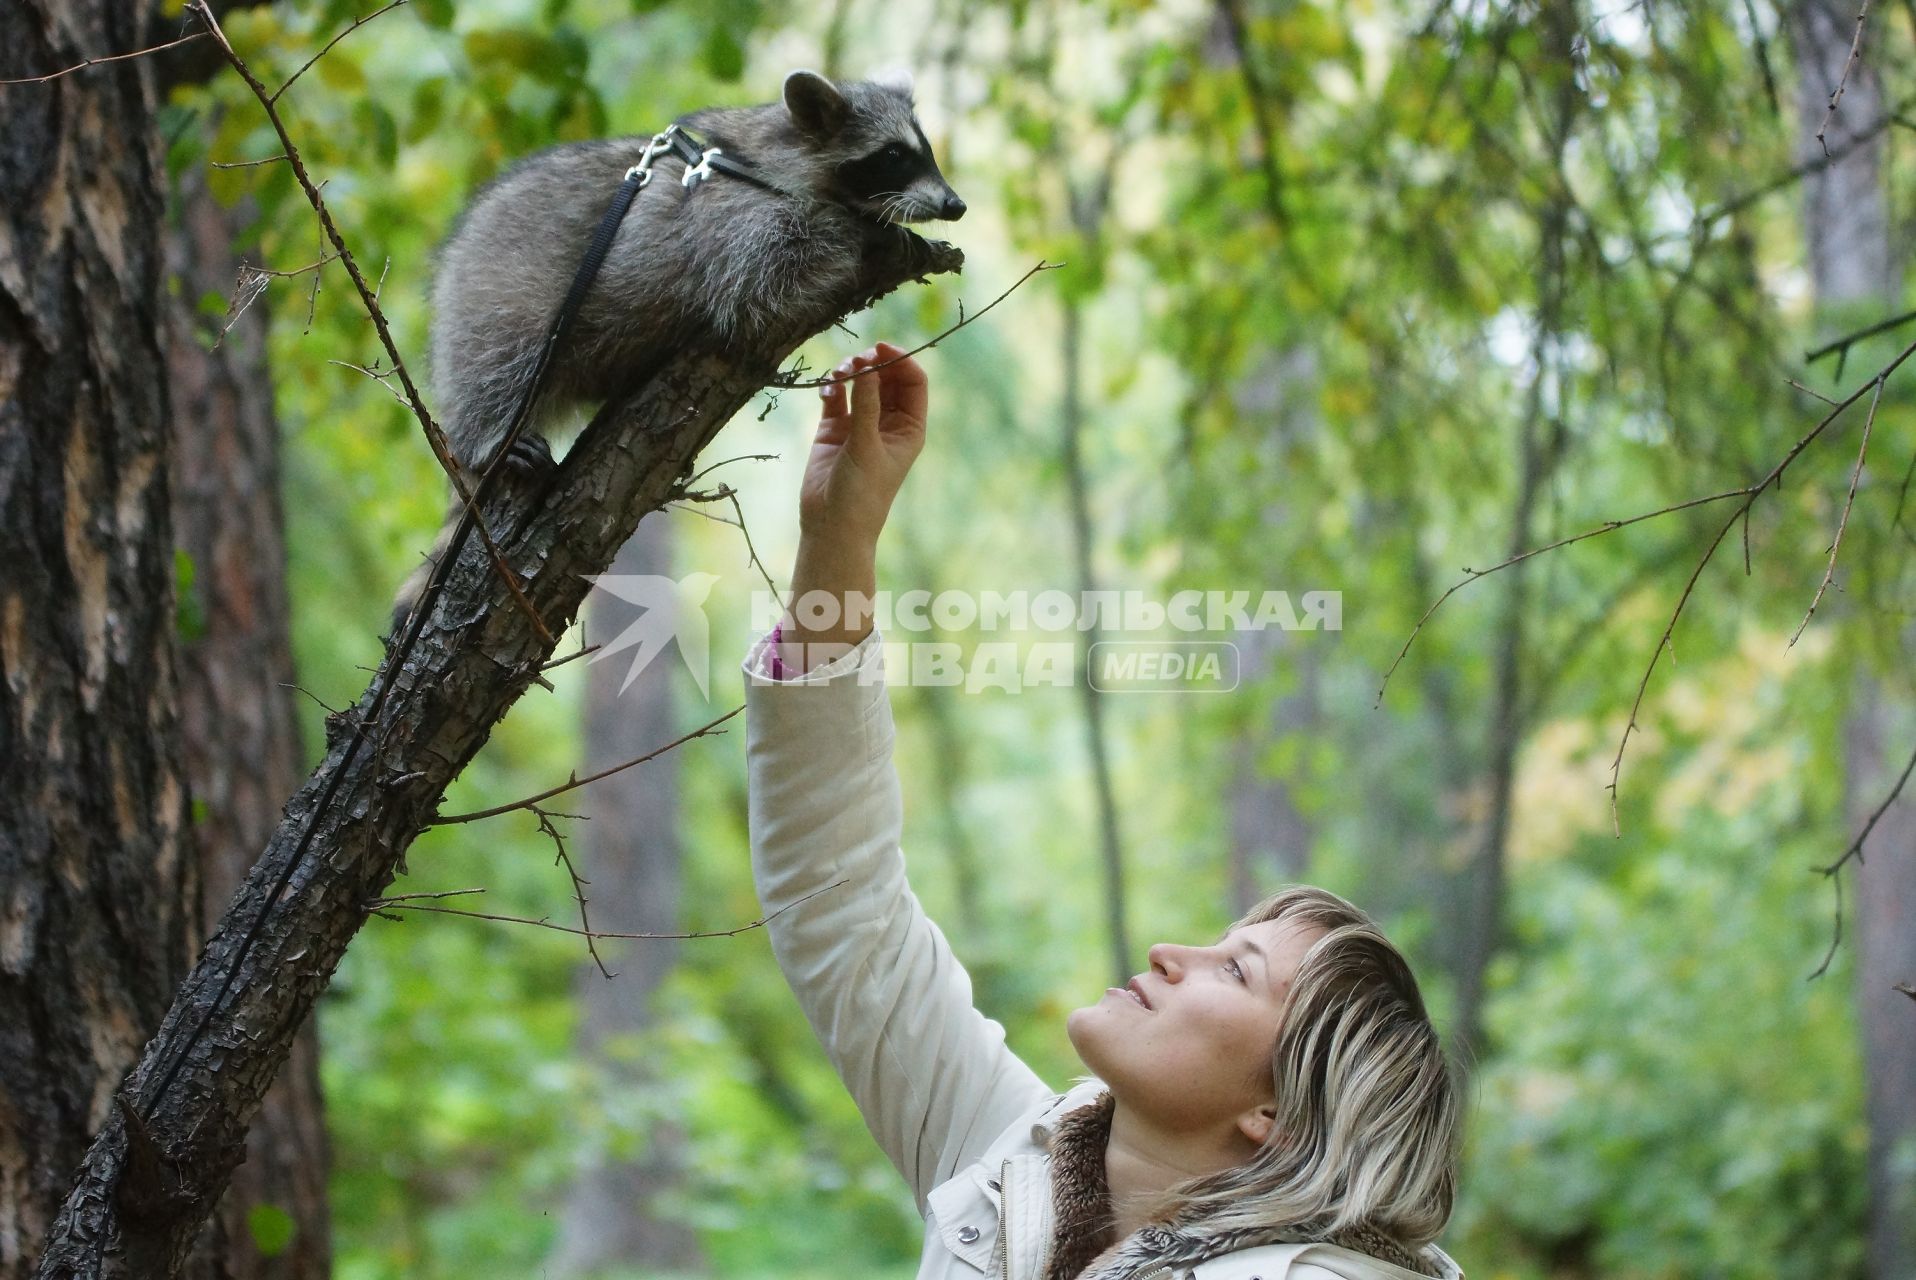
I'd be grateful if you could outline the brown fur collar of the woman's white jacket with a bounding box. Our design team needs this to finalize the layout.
[1044,1092,1443,1280]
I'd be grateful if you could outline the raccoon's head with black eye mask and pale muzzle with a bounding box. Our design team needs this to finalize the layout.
[786,71,966,222]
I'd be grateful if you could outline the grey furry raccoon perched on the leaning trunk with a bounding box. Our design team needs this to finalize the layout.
[431,71,964,473]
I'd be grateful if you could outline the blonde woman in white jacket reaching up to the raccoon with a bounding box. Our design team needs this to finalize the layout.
[745,343,1462,1280]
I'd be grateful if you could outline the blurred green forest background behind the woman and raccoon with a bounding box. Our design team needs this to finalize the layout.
[119,0,1916,1280]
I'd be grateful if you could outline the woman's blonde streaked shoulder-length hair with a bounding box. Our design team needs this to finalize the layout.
[1126,885,1462,1249]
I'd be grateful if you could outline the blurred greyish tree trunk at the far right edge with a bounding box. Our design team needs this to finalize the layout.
[1788,0,1916,1280]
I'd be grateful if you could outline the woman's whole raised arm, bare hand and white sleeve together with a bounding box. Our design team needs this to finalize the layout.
[745,343,1050,1207]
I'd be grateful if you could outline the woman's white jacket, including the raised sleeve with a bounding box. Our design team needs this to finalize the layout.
[745,630,1464,1280]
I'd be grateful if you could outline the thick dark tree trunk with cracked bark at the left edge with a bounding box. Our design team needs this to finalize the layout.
[0,0,199,1280]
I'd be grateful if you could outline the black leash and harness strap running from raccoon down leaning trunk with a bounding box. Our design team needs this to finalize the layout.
[132,125,780,1119]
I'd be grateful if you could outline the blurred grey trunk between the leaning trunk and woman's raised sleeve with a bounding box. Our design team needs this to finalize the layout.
[552,519,697,1276]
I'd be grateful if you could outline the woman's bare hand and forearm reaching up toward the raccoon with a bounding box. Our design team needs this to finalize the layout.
[778,343,929,671]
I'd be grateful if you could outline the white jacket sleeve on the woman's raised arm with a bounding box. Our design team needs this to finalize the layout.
[745,630,1052,1213]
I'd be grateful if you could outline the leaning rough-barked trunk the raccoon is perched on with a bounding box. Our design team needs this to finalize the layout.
[38,114,962,1278]
